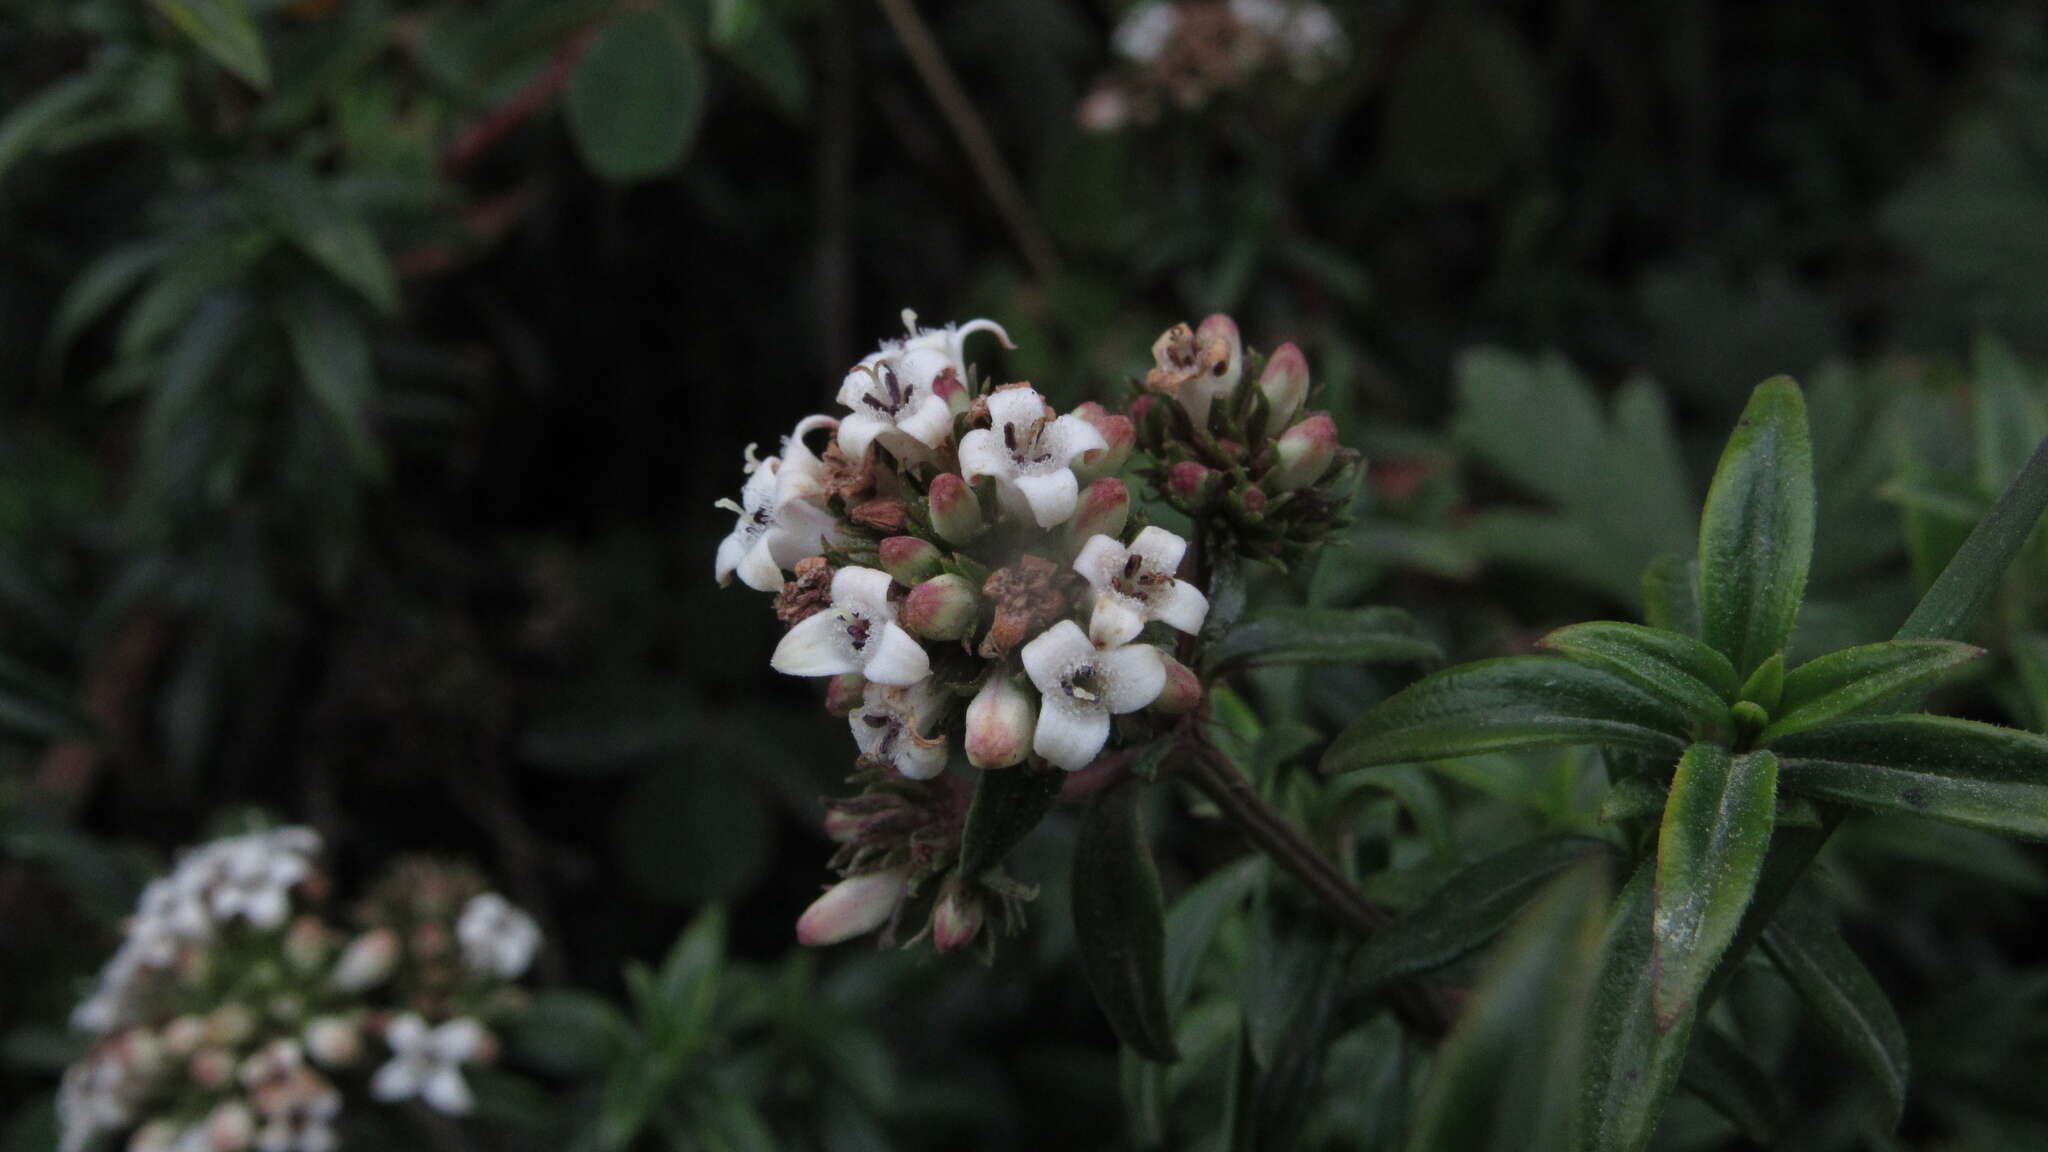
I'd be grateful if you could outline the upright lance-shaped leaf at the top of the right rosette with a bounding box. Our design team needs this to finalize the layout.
[1700,377,1815,676]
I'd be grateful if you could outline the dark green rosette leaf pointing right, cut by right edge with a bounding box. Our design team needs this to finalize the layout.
[1772,715,2048,840]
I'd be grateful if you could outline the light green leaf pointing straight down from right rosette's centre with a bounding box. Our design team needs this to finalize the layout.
[1651,744,1778,1029]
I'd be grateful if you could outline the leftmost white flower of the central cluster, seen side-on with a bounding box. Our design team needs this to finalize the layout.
[715,416,838,592]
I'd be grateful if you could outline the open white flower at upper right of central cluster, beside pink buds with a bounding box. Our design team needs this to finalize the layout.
[961,387,1110,529]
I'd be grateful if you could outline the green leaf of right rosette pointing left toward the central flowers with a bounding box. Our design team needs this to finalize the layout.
[1323,656,1692,773]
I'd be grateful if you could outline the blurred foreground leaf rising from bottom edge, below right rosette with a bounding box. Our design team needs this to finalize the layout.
[1407,865,1608,1152]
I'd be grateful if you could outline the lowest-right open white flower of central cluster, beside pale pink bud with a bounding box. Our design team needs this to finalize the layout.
[1024,619,1165,773]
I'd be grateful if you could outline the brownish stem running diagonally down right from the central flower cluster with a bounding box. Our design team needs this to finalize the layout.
[1176,738,1450,1037]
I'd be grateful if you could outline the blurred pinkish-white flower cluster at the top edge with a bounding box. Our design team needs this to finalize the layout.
[1081,0,1350,131]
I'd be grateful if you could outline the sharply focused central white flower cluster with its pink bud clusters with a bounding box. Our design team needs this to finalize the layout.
[715,314,1346,951]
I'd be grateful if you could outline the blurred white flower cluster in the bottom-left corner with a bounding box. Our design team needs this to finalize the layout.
[57,828,541,1152]
